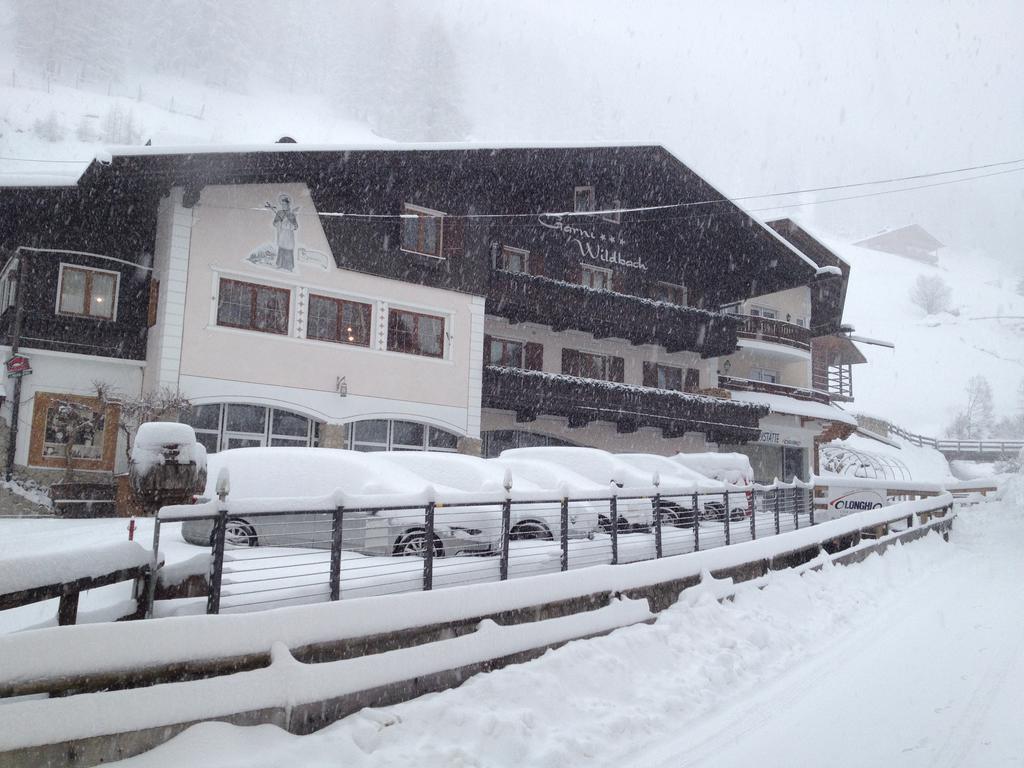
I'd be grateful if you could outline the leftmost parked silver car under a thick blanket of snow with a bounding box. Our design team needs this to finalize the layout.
[181,447,501,556]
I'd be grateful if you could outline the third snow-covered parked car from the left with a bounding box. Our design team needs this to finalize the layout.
[499,446,655,530]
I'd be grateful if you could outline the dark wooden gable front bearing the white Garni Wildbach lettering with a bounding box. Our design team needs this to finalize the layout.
[56,144,815,308]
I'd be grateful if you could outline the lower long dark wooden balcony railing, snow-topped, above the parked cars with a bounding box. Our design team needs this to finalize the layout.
[483,366,768,442]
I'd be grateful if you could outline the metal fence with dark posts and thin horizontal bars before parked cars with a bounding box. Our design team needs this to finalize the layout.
[150,482,814,614]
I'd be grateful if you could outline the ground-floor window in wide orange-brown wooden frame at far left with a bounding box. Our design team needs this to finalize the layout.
[29,392,118,471]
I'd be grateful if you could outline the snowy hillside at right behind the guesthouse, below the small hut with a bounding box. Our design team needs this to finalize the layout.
[822,231,1024,437]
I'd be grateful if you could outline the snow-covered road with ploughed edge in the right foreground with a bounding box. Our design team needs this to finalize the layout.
[108,481,1024,768]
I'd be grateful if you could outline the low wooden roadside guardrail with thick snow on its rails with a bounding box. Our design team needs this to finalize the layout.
[0,494,952,765]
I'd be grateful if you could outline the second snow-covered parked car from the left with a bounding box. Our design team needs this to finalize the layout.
[375,451,598,541]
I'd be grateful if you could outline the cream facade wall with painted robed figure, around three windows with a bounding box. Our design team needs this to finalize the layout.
[147,183,483,437]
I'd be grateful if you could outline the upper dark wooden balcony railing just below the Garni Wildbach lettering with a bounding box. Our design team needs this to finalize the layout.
[487,270,738,357]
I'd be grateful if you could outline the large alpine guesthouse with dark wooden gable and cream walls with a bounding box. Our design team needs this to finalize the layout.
[0,144,864,489]
